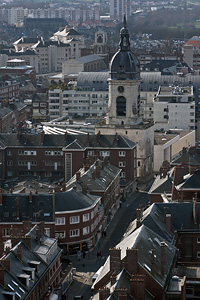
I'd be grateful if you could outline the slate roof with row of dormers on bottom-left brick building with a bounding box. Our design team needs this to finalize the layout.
[0,225,61,299]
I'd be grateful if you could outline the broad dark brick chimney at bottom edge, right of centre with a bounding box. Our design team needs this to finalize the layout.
[130,275,146,300]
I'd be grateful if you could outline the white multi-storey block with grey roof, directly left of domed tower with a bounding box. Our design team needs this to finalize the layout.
[48,72,108,120]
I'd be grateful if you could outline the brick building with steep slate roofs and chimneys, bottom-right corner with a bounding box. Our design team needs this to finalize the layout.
[92,203,200,300]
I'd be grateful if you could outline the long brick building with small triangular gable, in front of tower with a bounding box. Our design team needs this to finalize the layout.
[0,132,136,184]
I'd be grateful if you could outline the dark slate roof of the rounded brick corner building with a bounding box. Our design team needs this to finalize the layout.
[55,188,100,213]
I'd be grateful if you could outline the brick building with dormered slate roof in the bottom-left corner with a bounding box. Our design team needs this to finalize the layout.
[0,225,73,300]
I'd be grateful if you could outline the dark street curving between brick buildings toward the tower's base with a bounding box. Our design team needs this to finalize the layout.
[66,186,149,300]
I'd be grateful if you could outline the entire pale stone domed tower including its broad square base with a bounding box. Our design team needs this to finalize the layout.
[95,19,154,180]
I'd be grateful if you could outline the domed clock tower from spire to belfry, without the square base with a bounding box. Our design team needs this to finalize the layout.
[106,16,142,125]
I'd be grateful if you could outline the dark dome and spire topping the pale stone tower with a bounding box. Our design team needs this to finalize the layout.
[110,16,140,80]
